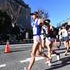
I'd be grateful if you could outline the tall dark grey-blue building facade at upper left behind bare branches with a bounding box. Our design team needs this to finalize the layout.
[0,0,31,28]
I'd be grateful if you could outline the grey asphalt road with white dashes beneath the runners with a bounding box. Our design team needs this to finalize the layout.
[0,44,70,70]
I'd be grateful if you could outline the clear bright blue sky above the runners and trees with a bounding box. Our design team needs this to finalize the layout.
[24,0,70,27]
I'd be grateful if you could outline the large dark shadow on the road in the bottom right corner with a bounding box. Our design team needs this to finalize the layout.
[45,56,70,70]
